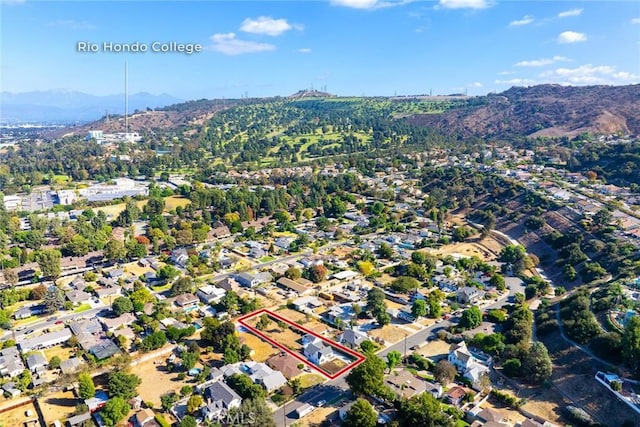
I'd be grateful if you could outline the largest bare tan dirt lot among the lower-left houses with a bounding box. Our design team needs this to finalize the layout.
[134,356,194,408]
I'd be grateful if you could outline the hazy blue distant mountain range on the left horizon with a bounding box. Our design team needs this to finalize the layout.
[0,90,183,124]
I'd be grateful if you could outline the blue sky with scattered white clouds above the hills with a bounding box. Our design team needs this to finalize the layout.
[0,0,640,99]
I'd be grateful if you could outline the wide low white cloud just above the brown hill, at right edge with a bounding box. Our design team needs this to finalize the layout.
[540,64,640,85]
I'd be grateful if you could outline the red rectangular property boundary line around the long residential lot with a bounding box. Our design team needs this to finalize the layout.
[238,308,366,380]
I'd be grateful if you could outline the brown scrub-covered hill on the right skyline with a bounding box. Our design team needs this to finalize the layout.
[409,85,640,138]
